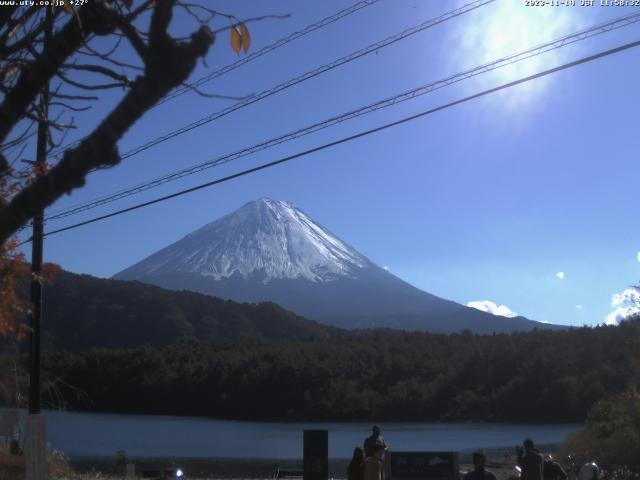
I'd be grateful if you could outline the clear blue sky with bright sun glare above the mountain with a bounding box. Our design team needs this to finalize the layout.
[17,0,640,325]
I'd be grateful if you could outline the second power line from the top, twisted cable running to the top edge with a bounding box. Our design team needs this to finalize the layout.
[53,0,495,167]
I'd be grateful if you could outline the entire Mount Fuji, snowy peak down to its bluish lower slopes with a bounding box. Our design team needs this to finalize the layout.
[113,198,553,333]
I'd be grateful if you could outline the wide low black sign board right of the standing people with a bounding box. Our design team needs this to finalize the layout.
[389,452,460,480]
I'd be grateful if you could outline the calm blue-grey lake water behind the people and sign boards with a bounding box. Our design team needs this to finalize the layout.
[17,411,580,459]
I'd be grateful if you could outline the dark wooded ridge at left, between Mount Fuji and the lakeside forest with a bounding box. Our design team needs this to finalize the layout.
[43,271,340,351]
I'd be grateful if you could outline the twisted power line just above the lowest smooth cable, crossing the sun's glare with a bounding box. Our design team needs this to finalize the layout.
[47,12,640,220]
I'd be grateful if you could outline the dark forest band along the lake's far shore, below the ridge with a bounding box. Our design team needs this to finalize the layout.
[44,320,640,422]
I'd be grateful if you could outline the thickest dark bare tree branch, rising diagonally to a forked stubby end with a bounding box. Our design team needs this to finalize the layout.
[0,0,214,243]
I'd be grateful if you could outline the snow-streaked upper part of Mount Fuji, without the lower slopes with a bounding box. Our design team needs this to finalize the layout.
[116,198,373,283]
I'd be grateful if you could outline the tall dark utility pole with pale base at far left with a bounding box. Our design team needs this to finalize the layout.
[25,7,53,480]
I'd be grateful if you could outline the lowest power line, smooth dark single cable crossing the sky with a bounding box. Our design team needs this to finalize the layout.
[21,40,640,245]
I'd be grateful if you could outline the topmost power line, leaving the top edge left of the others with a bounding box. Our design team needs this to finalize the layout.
[47,0,380,156]
